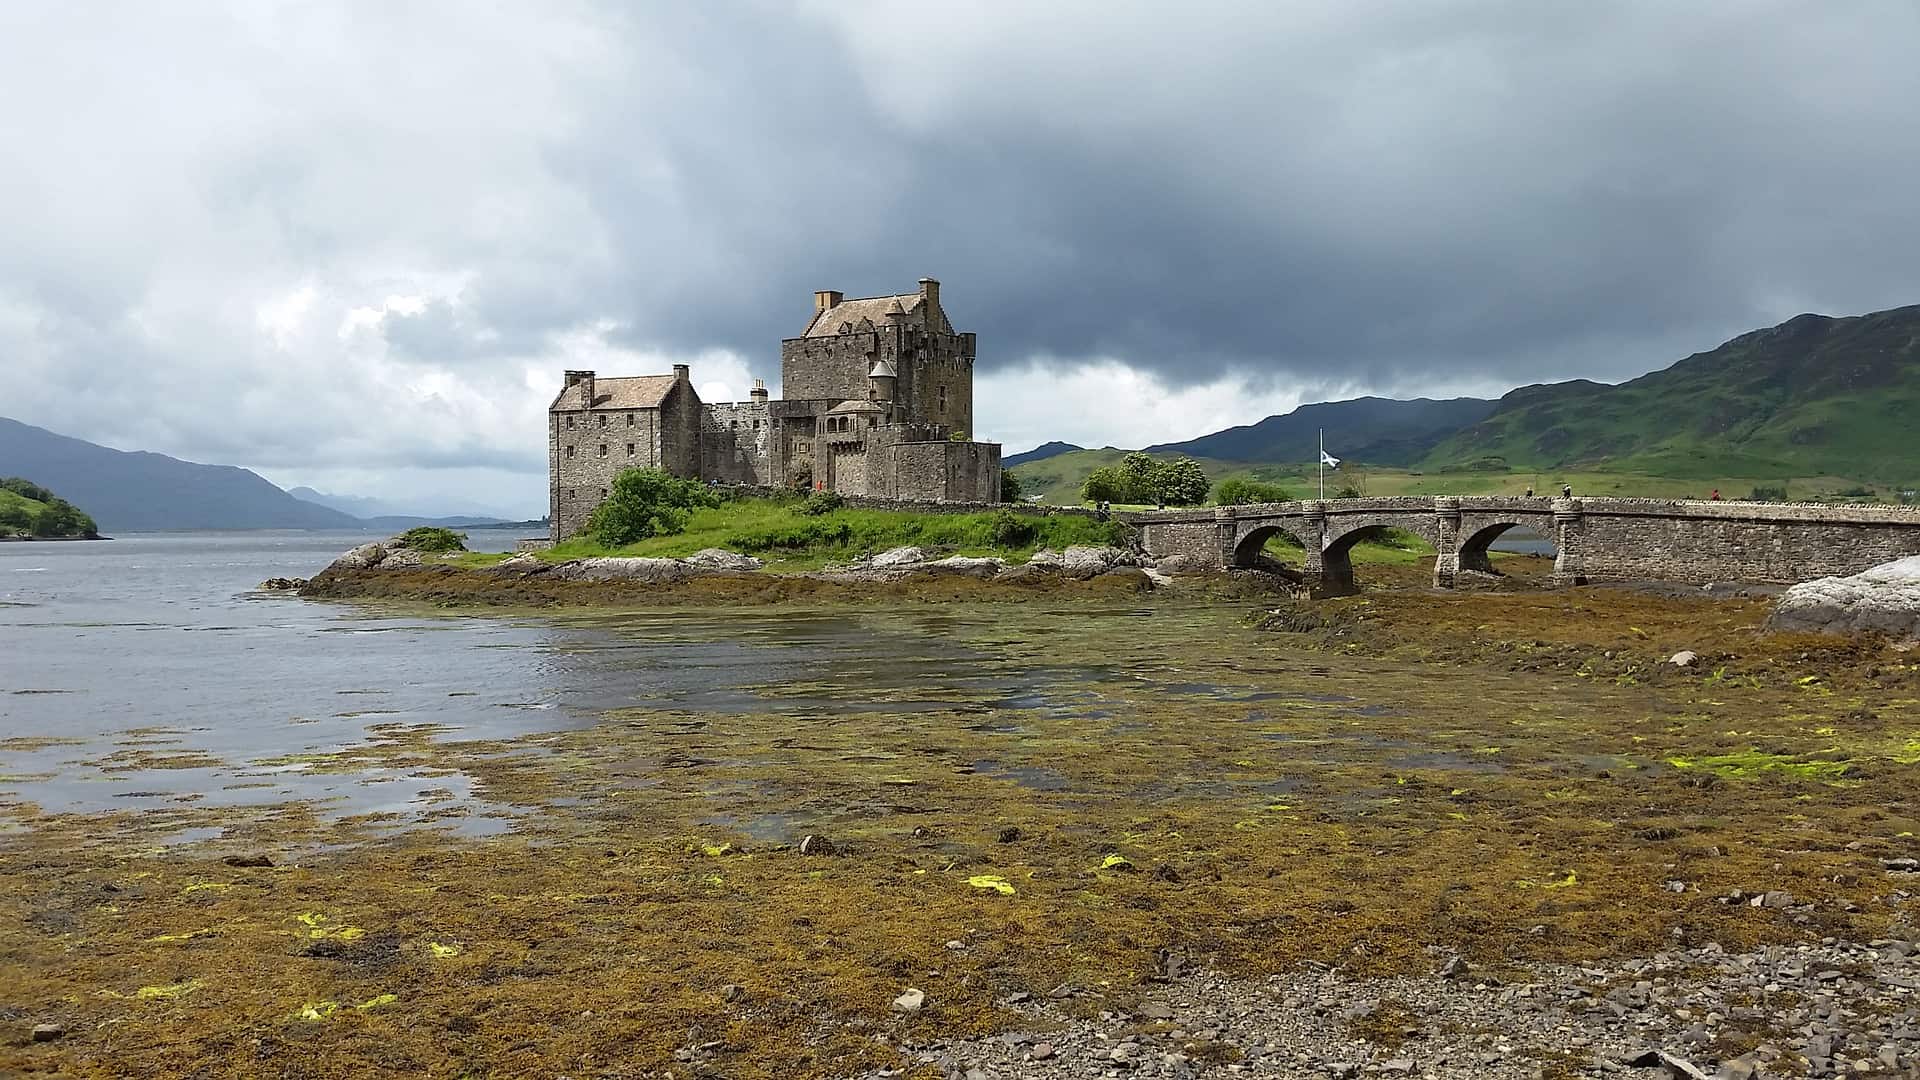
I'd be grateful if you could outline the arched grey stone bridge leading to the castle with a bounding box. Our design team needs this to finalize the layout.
[1121,496,1920,596]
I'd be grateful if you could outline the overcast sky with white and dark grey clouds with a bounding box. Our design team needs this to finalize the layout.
[0,0,1920,513]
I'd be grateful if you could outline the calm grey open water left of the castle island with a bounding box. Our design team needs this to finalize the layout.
[0,530,1033,832]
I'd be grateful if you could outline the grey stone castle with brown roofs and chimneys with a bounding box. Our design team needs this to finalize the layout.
[547,279,1000,542]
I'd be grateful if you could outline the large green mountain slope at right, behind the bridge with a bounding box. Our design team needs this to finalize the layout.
[1423,297,1920,474]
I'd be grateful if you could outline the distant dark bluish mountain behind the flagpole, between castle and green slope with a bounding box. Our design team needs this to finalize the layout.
[1146,398,1494,465]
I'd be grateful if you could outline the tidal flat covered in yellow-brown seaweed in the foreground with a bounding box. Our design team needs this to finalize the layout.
[0,588,1920,1078]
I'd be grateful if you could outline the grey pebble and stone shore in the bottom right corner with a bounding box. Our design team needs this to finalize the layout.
[864,926,1920,1080]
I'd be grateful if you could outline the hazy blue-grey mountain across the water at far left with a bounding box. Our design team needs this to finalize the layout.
[0,417,363,532]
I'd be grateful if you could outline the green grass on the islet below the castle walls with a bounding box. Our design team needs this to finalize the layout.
[449,498,1125,571]
